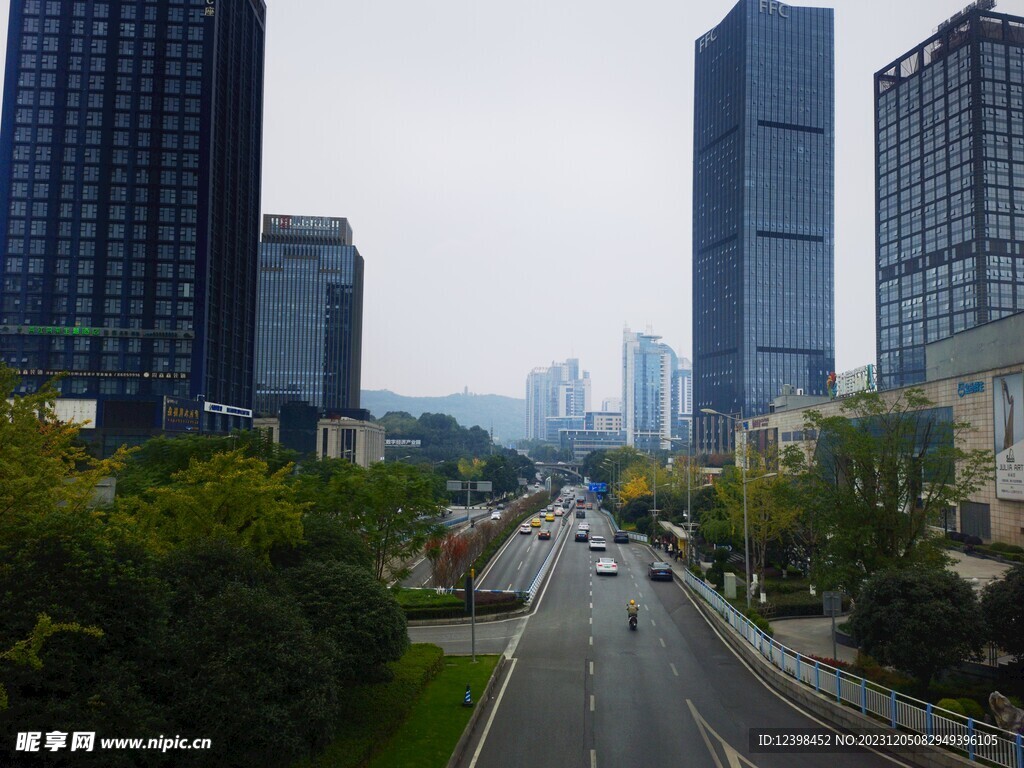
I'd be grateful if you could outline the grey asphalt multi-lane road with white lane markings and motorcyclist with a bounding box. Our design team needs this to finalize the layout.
[410,499,917,768]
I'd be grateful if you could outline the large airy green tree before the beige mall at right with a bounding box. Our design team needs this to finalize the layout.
[784,389,992,595]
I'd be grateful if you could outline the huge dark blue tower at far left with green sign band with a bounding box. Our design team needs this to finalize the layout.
[0,0,265,450]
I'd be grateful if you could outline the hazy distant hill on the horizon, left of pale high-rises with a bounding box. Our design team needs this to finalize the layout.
[359,389,526,443]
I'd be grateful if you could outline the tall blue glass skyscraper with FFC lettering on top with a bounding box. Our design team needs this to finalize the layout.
[692,0,836,452]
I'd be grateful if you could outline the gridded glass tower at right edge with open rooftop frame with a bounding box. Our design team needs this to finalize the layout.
[874,3,1024,389]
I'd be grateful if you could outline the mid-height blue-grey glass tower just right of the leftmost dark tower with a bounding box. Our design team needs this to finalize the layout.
[256,215,362,416]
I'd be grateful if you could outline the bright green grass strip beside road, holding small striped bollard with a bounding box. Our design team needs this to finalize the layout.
[370,655,499,768]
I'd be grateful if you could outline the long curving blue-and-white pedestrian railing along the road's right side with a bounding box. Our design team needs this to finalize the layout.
[683,570,1024,768]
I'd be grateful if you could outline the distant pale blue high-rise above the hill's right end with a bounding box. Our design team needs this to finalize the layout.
[526,357,590,441]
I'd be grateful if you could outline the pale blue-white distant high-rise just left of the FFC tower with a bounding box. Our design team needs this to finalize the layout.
[623,328,678,451]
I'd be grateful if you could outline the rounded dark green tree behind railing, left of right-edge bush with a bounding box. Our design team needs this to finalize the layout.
[850,567,983,689]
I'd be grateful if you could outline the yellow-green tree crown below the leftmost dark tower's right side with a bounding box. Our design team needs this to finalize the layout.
[120,451,303,558]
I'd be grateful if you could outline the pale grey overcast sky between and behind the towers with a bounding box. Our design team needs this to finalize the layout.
[0,0,1007,407]
